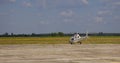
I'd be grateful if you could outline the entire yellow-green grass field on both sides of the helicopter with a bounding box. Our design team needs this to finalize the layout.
[0,36,120,44]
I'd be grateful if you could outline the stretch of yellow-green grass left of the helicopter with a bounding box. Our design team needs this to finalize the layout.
[0,37,69,44]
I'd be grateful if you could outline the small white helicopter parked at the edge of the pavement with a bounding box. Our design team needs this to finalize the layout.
[69,32,88,44]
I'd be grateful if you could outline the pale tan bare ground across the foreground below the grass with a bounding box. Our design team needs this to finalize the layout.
[0,44,120,63]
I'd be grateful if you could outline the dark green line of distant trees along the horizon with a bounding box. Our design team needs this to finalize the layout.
[0,32,120,37]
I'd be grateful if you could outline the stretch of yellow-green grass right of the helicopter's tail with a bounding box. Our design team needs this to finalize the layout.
[84,36,120,44]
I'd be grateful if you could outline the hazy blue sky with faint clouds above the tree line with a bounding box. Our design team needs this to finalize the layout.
[0,0,120,34]
